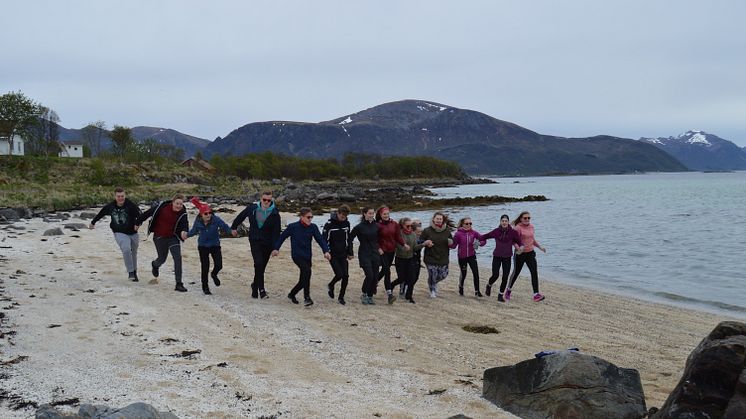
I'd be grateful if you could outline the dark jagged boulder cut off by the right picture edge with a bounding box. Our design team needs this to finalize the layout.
[653,322,746,419]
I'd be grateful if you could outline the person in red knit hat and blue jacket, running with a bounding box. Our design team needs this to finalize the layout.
[187,196,231,295]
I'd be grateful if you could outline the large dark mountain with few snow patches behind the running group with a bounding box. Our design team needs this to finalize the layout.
[204,100,686,175]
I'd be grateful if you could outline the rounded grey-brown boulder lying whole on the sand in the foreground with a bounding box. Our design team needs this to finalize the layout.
[482,351,646,419]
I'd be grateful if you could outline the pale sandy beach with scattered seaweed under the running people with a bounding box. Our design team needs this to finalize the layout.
[0,211,726,418]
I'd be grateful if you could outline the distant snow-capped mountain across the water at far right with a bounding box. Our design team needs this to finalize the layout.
[640,130,746,171]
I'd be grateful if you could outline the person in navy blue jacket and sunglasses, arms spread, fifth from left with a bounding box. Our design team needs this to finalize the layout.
[272,208,332,307]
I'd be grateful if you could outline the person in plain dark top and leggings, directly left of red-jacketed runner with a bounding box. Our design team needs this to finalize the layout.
[350,207,381,305]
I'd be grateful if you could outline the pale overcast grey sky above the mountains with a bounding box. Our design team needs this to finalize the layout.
[0,0,746,147]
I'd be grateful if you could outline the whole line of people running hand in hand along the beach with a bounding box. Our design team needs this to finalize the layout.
[89,188,546,306]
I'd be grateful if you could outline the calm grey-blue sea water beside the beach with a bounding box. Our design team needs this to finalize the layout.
[390,172,746,317]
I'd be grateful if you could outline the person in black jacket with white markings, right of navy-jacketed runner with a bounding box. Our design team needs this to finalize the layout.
[323,205,353,305]
